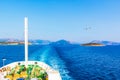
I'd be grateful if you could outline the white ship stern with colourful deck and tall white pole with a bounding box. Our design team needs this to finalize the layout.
[0,17,62,80]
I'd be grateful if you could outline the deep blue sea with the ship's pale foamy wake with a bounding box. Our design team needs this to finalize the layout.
[0,45,120,80]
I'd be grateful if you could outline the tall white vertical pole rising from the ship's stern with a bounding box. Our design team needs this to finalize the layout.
[24,17,28,66]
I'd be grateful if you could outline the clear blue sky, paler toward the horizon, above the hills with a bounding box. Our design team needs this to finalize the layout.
[0,0,120,42]
